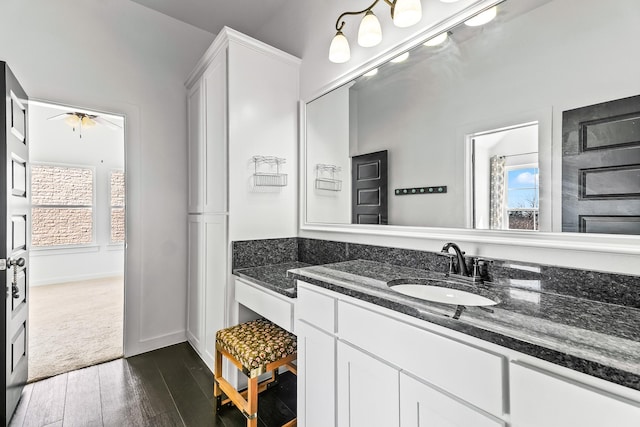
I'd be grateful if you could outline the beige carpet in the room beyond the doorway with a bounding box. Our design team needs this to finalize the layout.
[29,277,124,381]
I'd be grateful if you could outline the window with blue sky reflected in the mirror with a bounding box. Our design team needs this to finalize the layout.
[506,165,540,230]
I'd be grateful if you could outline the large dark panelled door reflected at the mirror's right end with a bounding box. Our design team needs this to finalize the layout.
[562,95,640,234]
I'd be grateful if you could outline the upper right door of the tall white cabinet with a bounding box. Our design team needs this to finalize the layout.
[202,51,227,213]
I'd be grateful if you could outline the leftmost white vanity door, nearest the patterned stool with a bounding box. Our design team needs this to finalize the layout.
[296,321,336,427]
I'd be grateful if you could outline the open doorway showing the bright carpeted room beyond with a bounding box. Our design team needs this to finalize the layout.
[28,102,125,382]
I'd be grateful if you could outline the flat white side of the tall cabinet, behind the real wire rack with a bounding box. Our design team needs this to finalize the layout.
[227,41,299,241]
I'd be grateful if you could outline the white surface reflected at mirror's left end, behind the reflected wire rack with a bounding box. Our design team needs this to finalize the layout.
[305,86,351,224]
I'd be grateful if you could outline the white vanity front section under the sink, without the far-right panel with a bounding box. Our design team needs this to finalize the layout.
[296,281,506,427]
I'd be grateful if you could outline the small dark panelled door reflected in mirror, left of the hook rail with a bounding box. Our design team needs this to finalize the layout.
[351,150,388,224]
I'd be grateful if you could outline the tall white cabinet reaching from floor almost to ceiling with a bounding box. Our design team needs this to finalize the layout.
[186,27,300,369]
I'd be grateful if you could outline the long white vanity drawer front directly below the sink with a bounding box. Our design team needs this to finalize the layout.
[338,301,506,417]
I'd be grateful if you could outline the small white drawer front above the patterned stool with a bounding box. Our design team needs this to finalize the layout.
[236,279,295,332]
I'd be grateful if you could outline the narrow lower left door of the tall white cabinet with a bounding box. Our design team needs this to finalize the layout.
[187,215,204,352]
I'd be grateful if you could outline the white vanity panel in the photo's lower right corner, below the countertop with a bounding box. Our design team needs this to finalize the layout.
[510,363,640,427]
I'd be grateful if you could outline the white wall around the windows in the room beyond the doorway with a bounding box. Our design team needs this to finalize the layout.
[29,103,124,286]
